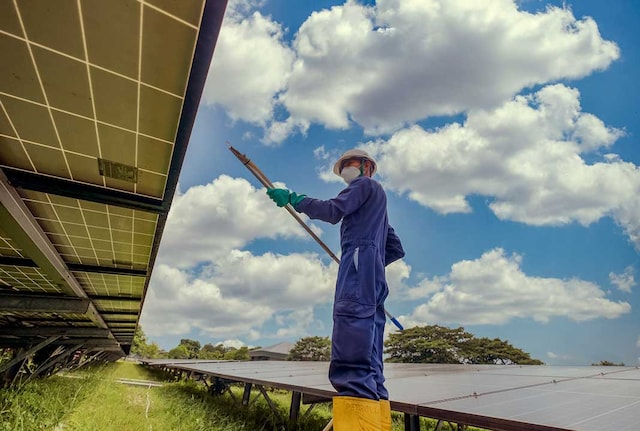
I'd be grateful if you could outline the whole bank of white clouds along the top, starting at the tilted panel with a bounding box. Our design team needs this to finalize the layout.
[204,0,620,144]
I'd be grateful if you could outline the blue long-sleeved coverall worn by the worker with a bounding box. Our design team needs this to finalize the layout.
[295,176,404,400]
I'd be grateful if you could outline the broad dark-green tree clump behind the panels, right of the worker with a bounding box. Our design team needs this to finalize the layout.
[385,325,542,365]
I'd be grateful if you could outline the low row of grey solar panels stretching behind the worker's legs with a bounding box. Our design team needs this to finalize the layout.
[144,360,640,431]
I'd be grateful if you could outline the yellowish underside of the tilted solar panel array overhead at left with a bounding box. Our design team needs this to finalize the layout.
[0,0,226,353]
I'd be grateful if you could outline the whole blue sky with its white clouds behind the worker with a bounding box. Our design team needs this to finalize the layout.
[141,0,640,365]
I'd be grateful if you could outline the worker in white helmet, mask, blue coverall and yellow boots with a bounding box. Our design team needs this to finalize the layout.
[267,149,404,431]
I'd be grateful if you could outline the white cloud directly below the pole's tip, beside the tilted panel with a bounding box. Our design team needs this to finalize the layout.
[158,175,321,268]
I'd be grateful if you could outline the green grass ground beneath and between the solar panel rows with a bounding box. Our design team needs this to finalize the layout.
[0,361,484,431]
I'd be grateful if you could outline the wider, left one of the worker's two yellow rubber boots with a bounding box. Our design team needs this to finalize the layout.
[333,397,380,431]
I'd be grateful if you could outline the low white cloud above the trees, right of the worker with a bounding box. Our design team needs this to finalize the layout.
[406,248,631,325]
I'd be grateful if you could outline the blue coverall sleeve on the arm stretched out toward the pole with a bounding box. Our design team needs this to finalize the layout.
[294,177,371,224]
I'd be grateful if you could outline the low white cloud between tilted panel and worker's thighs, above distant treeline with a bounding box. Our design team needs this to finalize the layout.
[142,250,336,339]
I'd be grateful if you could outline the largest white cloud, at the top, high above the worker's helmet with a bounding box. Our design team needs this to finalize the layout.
[281,0,619,134]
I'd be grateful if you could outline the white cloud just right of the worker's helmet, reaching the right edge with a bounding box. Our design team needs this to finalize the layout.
[367,84,640,244]
